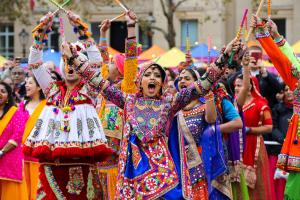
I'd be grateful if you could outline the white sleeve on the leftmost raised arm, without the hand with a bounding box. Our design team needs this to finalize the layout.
[28,46,54,96]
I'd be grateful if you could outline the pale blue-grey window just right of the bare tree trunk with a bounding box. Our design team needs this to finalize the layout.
[181,19,198,48]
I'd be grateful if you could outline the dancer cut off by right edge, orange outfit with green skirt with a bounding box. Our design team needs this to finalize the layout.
[252,16,300,200]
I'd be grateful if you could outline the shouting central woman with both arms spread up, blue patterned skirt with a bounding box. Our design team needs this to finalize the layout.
[62,28,239,199]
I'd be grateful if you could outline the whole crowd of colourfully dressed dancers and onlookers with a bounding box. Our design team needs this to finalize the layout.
[0,8,300,200]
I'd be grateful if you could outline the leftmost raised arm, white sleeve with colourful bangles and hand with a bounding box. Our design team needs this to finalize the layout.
[28,13,54,96]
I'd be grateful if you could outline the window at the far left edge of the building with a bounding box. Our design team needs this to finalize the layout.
[0,24,14,58]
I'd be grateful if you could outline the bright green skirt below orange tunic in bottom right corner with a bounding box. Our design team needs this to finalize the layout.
[284,172,300,200]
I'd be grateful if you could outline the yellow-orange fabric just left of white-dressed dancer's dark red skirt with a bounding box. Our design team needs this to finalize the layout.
[24,162,40,200]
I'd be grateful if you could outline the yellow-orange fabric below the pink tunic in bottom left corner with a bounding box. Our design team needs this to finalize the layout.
[0,180,28,200]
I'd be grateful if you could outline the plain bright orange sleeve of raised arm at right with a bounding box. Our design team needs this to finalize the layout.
[256,31,297,90]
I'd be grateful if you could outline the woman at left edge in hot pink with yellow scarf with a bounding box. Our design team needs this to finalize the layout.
[0,82,28,200]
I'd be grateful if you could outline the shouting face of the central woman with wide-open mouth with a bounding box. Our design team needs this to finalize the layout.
[141,65,163,98]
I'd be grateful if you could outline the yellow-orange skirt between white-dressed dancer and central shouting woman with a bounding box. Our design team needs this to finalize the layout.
[99,167,118,199]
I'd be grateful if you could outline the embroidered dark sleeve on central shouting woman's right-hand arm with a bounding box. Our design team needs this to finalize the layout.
[172,66,222,113]
